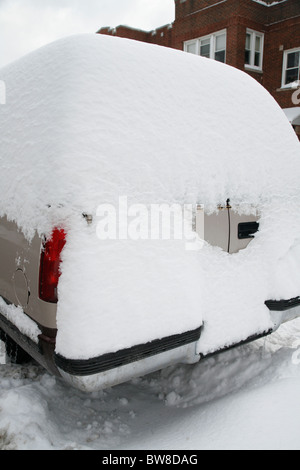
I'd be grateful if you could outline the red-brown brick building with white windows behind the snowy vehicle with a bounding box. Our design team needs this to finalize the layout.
[97,0,300,138]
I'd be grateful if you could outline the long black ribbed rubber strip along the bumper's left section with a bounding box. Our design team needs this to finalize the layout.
[55,327,201,377]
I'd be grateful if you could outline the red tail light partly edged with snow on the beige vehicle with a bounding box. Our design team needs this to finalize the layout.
[39,229,66,303]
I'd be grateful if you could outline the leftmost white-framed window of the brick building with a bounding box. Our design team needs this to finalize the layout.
[184,30,226,63]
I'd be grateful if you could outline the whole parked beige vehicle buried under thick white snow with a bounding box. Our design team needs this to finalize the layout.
[0,35,300,391]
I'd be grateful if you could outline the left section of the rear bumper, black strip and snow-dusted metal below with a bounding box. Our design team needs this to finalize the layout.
[55,328,201,392]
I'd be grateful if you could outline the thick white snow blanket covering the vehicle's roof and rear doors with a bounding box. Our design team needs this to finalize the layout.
[0,35,300,359]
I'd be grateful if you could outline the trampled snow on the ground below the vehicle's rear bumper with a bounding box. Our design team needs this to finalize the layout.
[0,319,300,450]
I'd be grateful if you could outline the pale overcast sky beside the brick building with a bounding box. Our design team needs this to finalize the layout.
[0,0,175,67]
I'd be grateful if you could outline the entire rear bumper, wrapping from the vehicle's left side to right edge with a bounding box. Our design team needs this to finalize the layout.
[0,297,300,392]
